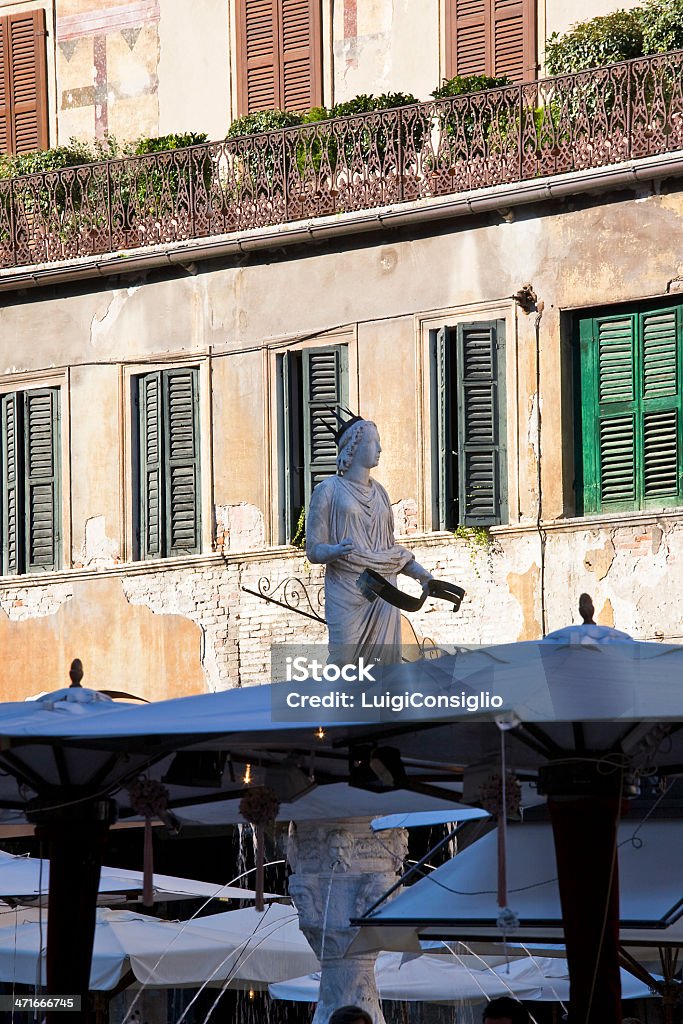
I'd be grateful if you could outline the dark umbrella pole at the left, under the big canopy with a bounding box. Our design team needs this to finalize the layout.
[32,796,114,1024]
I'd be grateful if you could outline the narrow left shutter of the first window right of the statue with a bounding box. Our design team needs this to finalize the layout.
[435,327,458,529]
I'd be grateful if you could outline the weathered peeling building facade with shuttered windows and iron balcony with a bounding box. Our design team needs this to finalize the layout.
[0,0,683,699]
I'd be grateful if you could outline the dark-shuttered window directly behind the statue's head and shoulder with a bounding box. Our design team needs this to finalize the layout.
[279,345,348,541]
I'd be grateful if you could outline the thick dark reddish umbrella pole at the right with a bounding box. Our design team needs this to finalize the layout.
[548,796,622,1024]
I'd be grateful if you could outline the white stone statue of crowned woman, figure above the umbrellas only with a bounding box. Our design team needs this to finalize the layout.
[306,417,432,662]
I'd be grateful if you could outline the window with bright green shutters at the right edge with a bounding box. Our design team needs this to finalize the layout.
[578,304,683,513]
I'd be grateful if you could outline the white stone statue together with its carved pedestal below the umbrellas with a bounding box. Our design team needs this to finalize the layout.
[288,416,421,1024]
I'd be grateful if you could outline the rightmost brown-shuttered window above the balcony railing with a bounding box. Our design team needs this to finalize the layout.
[445,0,538,82]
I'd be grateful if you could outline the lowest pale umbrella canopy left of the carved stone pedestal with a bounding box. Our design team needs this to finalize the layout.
[0,903,318,991]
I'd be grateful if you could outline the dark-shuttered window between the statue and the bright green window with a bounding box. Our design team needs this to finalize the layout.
[432,321,507,529]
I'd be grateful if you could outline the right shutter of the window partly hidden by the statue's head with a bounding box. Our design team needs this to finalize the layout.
[302,345,348,508]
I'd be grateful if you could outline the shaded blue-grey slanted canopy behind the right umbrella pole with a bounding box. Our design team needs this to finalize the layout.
[351,819,683,952]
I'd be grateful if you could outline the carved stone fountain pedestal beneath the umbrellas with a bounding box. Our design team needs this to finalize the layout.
[287,818,408,1024]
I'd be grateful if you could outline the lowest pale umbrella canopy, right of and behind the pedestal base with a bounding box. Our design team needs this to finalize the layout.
[268,952,653,1002]
